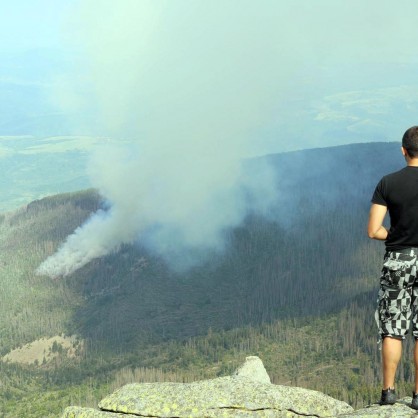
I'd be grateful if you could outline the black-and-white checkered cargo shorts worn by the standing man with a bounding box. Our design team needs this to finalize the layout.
[375,249,418,339]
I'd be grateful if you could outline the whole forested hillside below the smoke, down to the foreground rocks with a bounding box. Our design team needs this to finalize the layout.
[0,143,411,416]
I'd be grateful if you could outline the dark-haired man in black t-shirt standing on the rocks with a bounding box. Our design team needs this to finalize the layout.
[368,126,418,409]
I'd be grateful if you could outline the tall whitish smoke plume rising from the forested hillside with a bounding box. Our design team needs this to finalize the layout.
[37,1,275,277]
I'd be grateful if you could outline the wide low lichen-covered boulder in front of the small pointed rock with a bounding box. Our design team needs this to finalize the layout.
[99,376,353,418]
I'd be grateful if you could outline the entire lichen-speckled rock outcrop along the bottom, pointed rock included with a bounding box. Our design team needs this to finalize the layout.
[61,357,416,418]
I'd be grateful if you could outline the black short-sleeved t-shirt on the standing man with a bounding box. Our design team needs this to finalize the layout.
[372,166,418,251]
